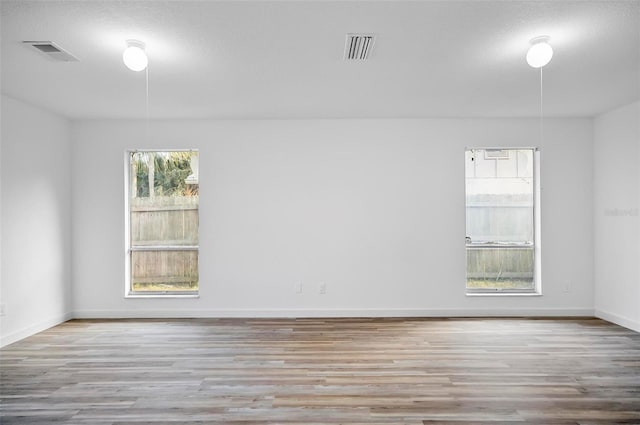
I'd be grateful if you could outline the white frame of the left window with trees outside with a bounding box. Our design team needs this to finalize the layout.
[124,148,200,298]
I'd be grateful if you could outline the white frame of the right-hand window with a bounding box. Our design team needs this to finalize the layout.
[464,146,542,296]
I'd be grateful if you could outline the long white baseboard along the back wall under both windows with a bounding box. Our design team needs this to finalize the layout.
[73,309,594,319]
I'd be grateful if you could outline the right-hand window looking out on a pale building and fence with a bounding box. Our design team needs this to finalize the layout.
[465,149,540,293]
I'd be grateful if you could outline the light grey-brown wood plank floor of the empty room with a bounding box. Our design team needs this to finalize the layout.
[0,319,640,425]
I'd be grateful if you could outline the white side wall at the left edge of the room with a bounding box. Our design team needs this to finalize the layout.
[0,95,71,345]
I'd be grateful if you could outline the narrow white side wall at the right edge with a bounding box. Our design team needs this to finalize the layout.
[594,102,640,332]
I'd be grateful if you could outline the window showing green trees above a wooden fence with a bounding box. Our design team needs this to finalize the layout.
[126,151,199,295]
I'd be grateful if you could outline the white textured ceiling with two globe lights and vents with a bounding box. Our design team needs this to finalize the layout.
[1,0,640,119]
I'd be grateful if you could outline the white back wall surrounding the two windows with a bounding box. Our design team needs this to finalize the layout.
[72,119,594,317]
